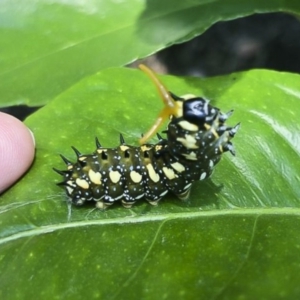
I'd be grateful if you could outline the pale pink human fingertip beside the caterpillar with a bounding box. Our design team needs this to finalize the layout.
[0,112,35,194]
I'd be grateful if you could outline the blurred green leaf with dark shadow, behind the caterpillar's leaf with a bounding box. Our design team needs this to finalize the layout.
[0,0,300,106]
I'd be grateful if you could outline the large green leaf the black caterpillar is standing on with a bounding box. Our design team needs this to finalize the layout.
[0,69,300,299]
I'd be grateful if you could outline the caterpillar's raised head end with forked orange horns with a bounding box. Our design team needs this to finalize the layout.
[140,65,239,160]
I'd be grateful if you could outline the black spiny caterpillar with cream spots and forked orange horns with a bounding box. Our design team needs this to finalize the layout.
[54,65,239,209]
